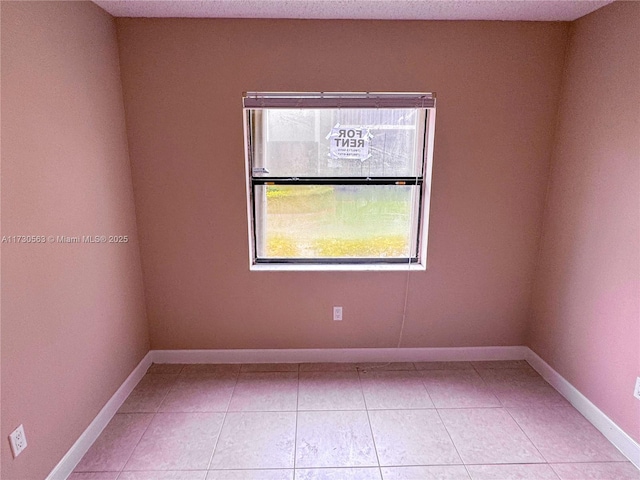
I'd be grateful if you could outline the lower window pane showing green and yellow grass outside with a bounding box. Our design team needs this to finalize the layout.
[256,185,419,259]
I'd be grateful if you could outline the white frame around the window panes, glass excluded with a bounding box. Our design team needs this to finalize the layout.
[243,92,436,271]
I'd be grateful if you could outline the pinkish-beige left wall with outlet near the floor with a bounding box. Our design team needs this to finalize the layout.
[0,1,149,480]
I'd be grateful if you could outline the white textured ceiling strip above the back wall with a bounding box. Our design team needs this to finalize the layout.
[93,0,613,21]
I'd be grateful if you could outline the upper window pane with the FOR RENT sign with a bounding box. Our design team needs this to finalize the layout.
[252,108,424,177]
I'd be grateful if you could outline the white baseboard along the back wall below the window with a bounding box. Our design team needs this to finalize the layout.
[150,346,529,363]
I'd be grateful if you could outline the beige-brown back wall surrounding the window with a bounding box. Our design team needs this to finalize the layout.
[116,18,568,349]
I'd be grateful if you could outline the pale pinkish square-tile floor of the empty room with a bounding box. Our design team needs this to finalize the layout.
[69,361,640,480]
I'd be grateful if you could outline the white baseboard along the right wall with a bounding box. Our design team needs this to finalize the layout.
[525,348,640,468]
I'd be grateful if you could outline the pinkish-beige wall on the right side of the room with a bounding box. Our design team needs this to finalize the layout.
[529,2,640,440]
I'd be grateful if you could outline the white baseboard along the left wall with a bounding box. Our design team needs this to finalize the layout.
[46,352,152,480]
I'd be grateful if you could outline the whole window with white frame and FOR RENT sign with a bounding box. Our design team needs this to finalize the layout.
[243,93,435,269]
